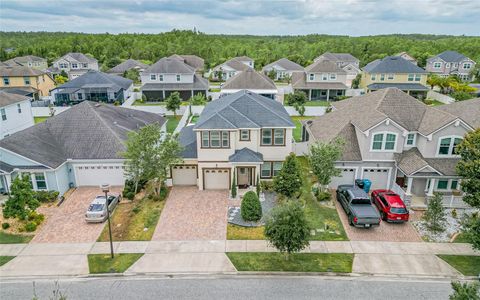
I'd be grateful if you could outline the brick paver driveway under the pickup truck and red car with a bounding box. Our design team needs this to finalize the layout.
[335,200,422,242]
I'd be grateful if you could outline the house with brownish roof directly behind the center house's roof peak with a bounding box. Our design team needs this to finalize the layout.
[220,68,278,99]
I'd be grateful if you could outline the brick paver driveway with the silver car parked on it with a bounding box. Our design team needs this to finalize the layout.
[32,187,122,243]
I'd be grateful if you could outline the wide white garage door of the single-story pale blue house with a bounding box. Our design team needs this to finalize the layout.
[75,164,125,186]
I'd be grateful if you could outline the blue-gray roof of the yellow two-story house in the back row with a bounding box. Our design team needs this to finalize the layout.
[363,56,427,74]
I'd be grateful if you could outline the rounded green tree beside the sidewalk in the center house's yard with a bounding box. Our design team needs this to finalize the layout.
[265,201,310,259]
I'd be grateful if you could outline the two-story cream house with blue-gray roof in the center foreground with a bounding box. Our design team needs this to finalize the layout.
[171,91,295,190]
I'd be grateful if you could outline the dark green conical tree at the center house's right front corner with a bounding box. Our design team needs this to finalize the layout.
[273,153,302,198]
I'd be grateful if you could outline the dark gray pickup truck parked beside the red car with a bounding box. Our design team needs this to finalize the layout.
[337,185,380,228]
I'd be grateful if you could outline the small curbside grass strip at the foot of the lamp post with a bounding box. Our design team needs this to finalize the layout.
[88,253,143,274]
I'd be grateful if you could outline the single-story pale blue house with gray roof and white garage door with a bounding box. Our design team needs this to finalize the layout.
[0,101,165,194]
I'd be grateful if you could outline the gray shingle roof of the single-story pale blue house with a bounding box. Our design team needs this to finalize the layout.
[0,101,165,168]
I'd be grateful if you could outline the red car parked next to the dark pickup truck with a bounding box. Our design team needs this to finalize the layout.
[372,190,409,223]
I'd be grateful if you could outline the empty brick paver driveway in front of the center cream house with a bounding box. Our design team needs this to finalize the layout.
[152,186,228,241]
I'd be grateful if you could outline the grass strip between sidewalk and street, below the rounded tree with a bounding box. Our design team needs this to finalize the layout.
[227,252,353,273]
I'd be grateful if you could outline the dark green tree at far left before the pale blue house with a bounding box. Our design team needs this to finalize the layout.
[3,175,40,220]
